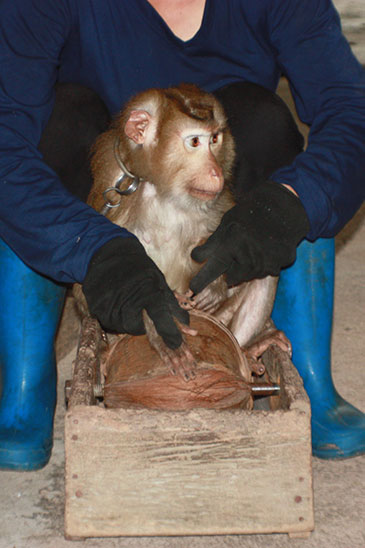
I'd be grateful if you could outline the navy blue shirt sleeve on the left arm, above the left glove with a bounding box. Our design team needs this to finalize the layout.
[0,0,130,282]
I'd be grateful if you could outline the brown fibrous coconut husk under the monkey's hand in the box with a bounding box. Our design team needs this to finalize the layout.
[103,311,253,411]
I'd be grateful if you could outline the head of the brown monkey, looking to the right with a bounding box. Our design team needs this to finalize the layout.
[121,85,234,209]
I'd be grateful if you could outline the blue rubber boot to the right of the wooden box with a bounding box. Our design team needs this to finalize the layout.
[273,239,365,459]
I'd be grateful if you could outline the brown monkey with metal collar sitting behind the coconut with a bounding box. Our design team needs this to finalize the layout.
[76,84,290,380]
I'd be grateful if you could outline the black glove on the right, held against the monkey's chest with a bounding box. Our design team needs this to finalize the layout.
[190,182,310,293]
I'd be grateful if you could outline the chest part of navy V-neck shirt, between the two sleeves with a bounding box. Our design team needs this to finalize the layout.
[59,0,279,113]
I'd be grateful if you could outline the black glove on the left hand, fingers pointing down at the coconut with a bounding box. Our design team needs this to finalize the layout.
[83,237,189,349]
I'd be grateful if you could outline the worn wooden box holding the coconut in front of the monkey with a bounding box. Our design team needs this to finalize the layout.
[65,316,314,539]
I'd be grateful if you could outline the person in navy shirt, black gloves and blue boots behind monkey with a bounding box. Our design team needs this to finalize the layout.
[0,0,365,470]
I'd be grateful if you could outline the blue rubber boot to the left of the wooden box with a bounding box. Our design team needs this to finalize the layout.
[0,240,65,470]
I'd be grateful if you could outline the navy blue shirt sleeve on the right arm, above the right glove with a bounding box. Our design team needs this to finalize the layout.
[267,0,365,240]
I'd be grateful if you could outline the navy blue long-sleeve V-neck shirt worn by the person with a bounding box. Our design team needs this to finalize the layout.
[0,0,365,282]
